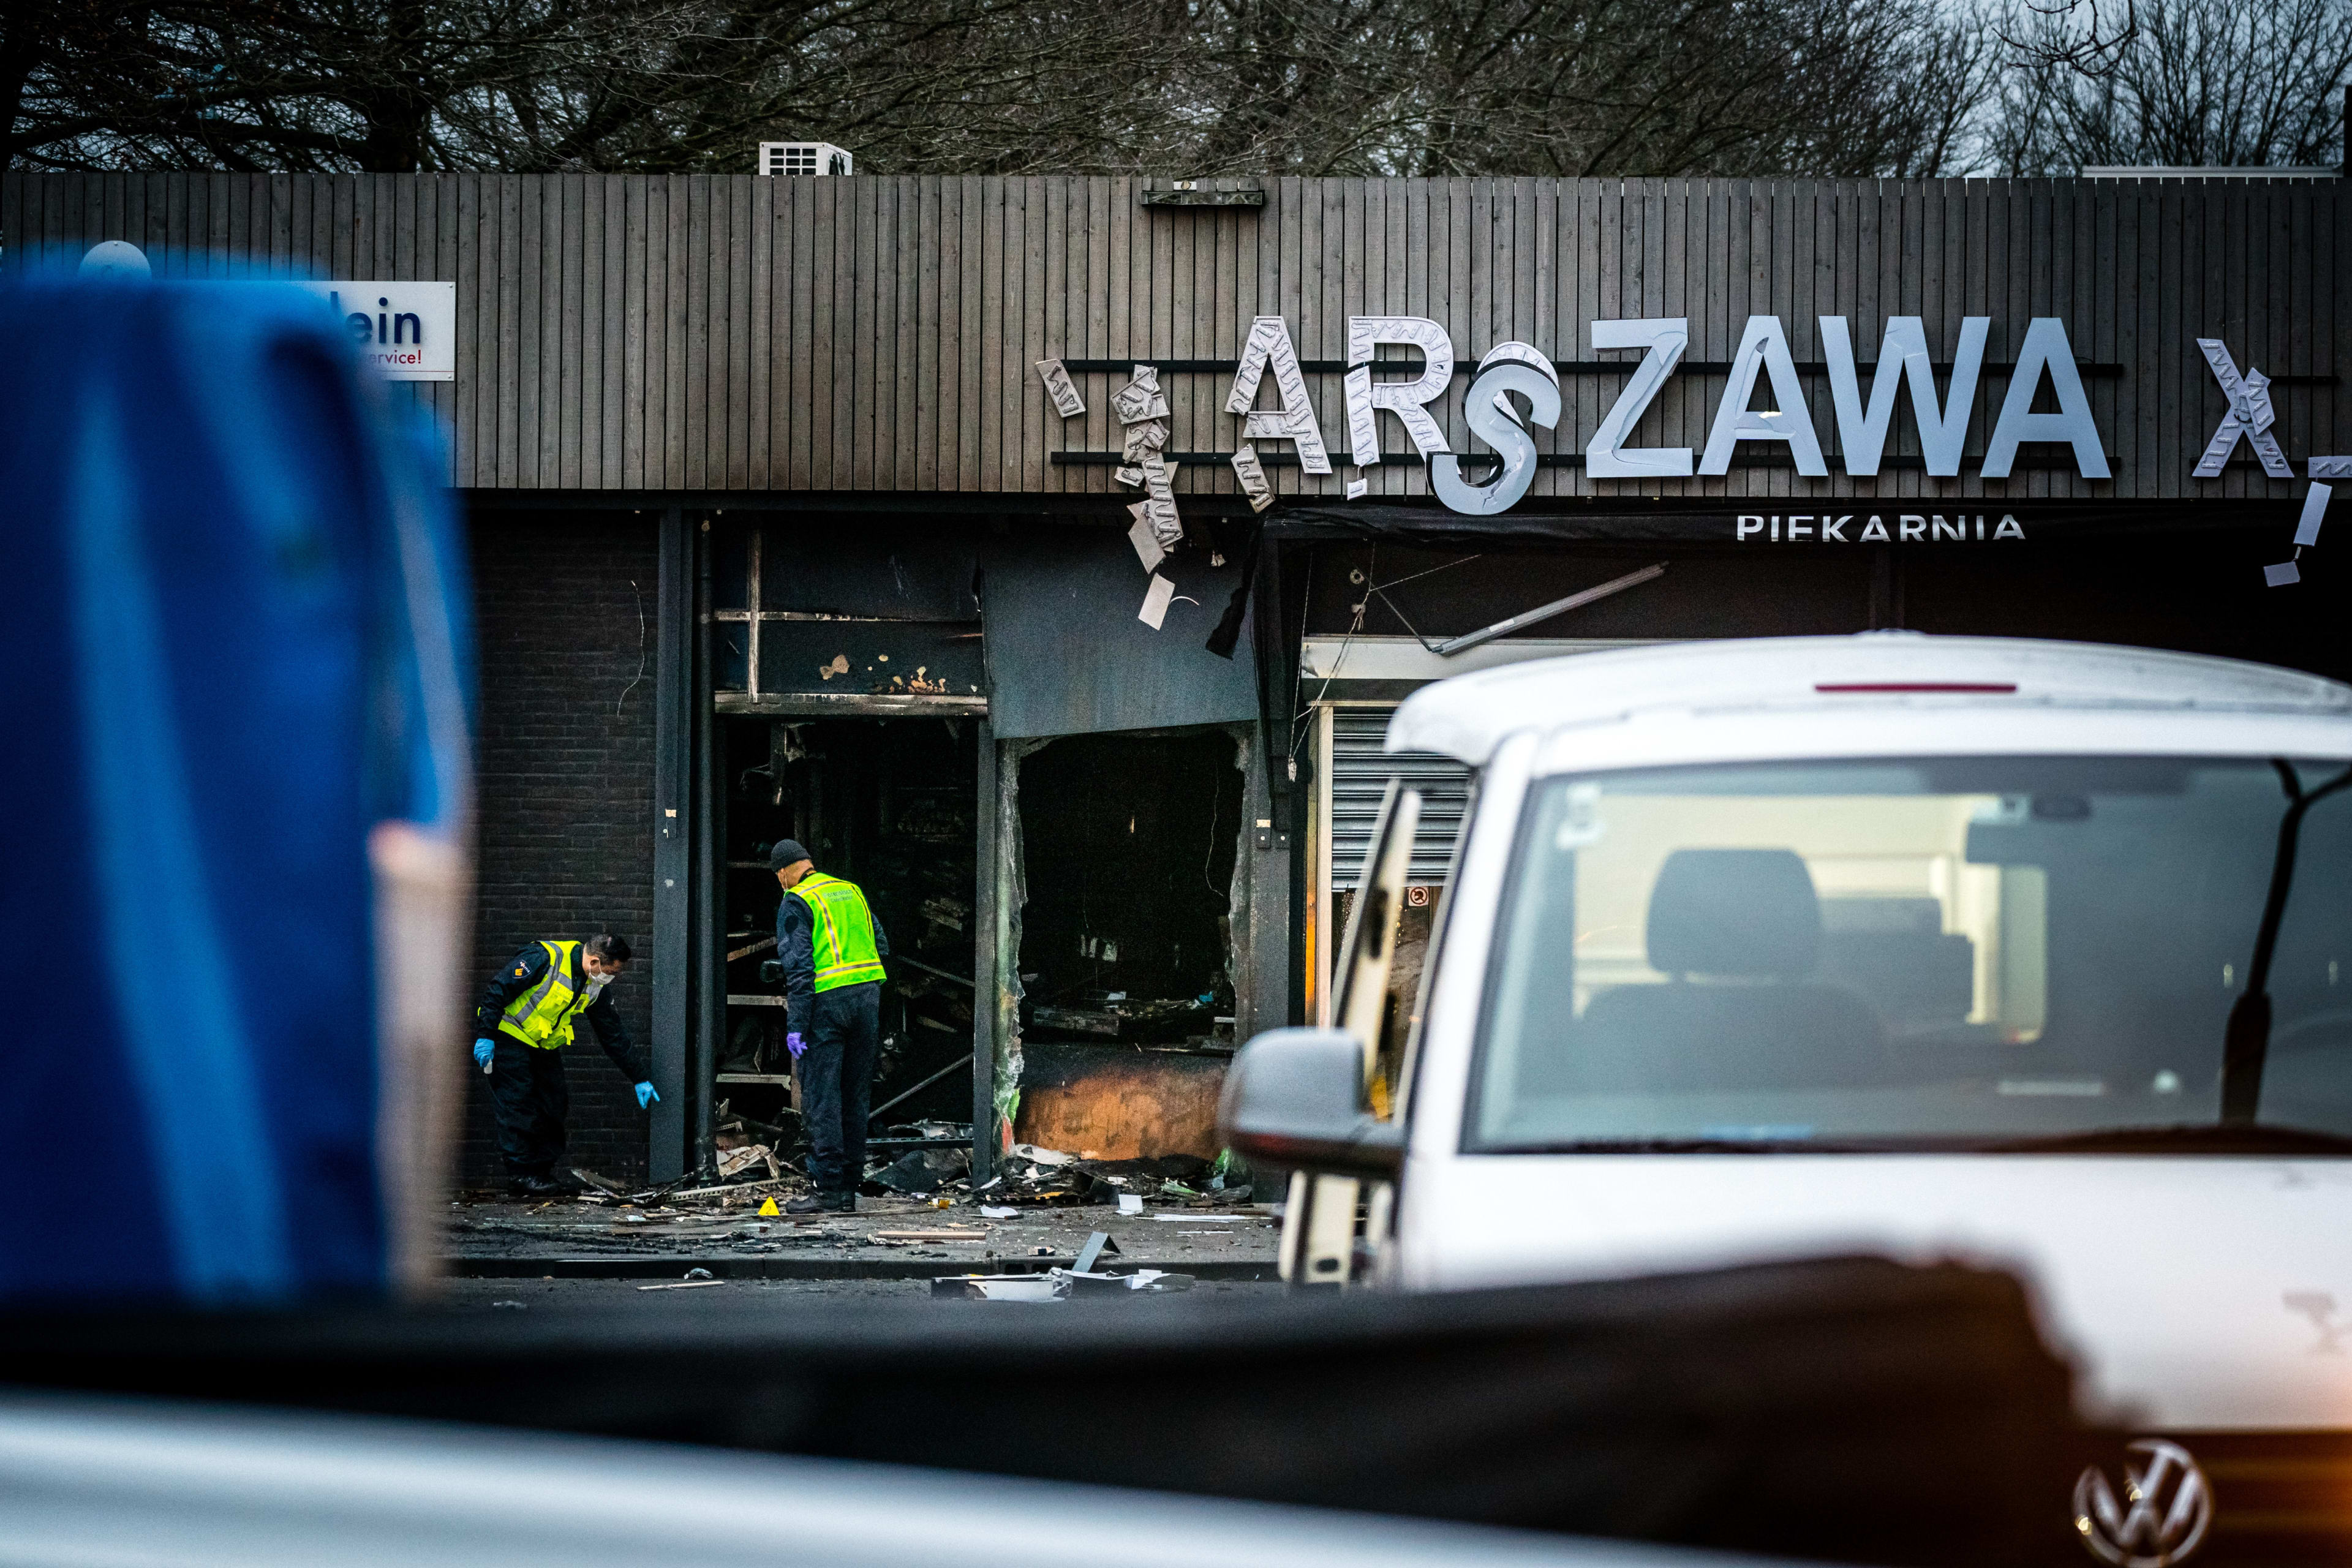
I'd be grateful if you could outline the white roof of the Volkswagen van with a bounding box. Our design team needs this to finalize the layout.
[1388,632,2352,766]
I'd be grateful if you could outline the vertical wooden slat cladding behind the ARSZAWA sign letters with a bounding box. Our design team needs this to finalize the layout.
[0,174,2352,503]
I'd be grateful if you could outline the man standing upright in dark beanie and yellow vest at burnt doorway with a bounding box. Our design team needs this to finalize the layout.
[767,839,889,1213]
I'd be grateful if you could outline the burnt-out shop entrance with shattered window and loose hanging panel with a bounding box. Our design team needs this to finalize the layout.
[708,510,1258,1197]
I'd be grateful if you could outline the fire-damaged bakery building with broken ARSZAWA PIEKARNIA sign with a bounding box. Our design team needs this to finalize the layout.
[13,174,2352,1197]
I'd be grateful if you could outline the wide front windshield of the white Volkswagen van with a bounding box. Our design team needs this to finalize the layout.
[1465,757,2352,1152]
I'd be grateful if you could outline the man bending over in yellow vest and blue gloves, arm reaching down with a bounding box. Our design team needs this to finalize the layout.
[473,936,661,1197]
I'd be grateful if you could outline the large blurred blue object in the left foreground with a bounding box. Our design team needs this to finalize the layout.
[0,282,473,1305]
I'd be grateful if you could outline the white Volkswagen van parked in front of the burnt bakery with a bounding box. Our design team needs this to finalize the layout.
[1226,632,2352,1563]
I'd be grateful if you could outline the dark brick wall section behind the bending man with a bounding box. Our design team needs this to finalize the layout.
[461,510,658,1183]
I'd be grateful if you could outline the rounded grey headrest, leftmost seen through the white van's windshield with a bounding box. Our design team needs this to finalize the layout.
[1649,849,1820,980]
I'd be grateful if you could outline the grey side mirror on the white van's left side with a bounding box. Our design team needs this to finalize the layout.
[1216,1030,1404,1180]
